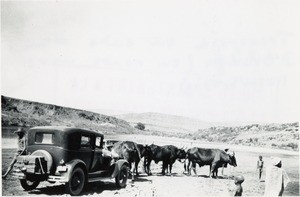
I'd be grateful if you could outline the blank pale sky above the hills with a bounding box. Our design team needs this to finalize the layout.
[1,0,300,122]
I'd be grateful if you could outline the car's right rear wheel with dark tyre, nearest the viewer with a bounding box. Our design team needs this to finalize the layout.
[65,167,85,196]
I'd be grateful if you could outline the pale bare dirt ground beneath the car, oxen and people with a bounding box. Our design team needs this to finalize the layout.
[2,136,299,196]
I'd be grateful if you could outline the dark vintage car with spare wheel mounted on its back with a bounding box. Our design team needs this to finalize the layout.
[13,126,129,195]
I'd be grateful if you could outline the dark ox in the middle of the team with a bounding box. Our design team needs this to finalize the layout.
[145,144,186,175]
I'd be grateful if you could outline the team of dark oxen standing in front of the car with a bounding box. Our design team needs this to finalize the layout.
[111,141,237,180]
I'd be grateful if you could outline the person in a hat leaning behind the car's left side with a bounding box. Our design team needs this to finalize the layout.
[2,128,26,179]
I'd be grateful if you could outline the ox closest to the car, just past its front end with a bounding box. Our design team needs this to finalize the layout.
[112,141,141,181]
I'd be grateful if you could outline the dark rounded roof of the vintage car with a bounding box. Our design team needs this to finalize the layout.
[30,126,103,136]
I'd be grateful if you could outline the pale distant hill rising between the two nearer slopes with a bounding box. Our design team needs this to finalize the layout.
[116,112,222,133]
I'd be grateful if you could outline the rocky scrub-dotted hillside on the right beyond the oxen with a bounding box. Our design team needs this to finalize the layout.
[181,122,299,151]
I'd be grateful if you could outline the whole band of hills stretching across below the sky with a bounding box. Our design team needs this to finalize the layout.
[1,96,299,151]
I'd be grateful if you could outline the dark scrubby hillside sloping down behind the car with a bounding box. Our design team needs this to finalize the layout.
[1,96,136,133]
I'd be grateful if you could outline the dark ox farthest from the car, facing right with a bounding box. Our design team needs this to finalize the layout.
[187,147,237,177]
